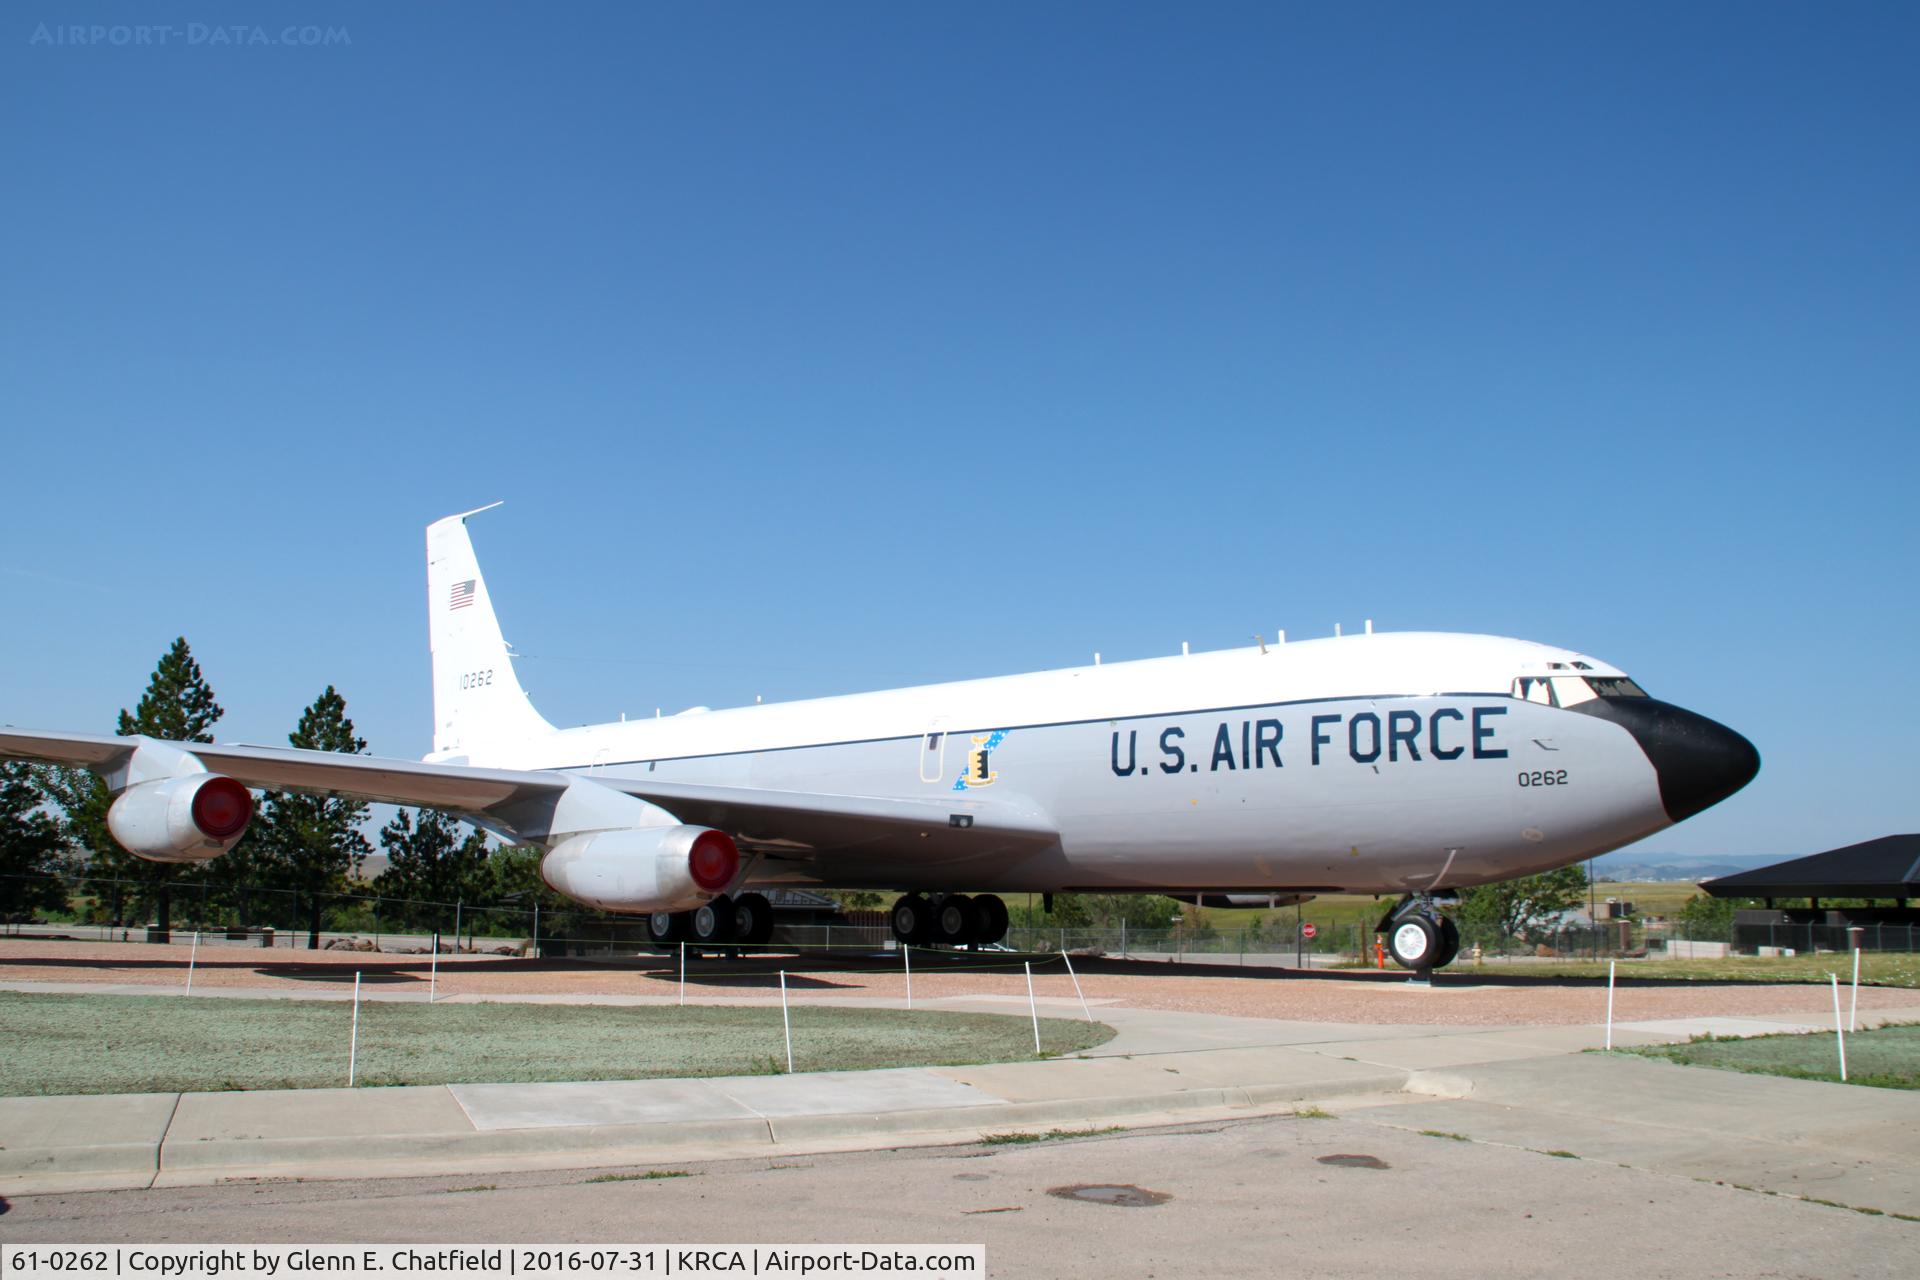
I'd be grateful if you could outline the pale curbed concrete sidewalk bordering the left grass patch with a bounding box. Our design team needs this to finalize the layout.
[0,998,1407,1194]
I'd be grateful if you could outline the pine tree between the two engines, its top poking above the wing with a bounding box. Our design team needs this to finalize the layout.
[255,685,372,948]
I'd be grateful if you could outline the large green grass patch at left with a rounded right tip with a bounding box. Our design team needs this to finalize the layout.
[0,992,1114,1094]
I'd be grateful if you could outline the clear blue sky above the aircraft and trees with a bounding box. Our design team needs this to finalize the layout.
[0,0,1920,856]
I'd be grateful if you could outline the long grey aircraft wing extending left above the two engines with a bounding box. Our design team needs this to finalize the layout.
[0,729,1058,862]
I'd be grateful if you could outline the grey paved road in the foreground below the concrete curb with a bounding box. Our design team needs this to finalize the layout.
[0,1107,1920,1280]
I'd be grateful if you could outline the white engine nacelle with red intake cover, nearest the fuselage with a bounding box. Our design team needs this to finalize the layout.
[540,825,739,912]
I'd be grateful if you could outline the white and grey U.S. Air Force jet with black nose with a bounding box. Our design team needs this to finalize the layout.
[0,507,1761,969]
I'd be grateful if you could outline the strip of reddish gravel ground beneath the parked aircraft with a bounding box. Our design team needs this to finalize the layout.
[0,938,1920,1027]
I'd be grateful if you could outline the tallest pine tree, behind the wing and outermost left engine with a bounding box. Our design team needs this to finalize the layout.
[44,635,223,936]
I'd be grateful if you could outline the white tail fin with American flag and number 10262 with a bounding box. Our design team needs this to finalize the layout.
[426,503,553,764]
